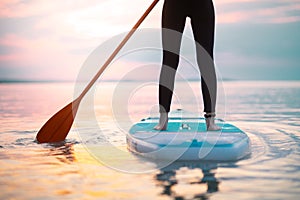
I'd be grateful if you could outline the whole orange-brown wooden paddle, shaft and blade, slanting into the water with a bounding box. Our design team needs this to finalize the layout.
[36,0,159,143]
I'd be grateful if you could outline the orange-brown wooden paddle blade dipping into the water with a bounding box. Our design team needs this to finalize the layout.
[36,99,81,143]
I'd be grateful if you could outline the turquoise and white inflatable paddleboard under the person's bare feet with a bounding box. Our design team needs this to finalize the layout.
[126,111,250,161]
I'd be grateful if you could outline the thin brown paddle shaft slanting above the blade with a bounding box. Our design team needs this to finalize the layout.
[78,0,159,99]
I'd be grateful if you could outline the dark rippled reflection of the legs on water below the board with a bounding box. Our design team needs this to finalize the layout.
[156,162,220,199]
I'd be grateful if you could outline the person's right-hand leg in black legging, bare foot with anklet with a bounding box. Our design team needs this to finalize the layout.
[190,0,220,130]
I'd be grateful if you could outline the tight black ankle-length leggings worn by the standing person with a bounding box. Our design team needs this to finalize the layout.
[159,0,217,113]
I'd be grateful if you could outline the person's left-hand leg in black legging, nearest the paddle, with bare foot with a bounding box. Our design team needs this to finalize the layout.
[155,0,186,130]
